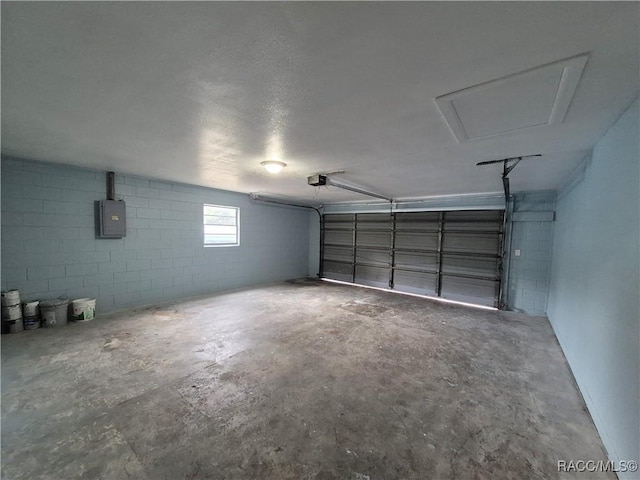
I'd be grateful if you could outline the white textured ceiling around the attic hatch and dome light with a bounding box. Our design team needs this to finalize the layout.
[2,2,640,203]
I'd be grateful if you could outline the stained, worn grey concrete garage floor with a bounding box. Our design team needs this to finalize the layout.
[2,280,615,480]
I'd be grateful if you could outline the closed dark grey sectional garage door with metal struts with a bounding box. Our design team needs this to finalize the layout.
[322,210,504,306]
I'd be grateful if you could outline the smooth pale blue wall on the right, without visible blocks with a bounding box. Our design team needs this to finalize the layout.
[548,100,640,479]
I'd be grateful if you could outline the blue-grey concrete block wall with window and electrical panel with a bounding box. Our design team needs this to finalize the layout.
[1,157,309,312]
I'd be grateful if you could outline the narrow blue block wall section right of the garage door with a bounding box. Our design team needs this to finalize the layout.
[507,191,556,315]
